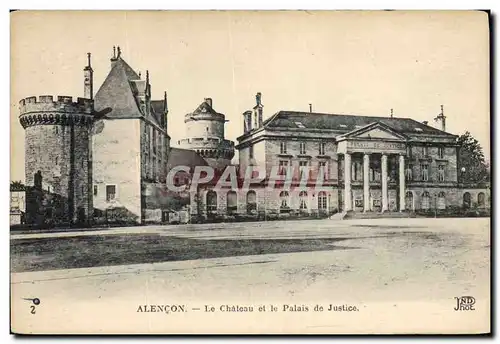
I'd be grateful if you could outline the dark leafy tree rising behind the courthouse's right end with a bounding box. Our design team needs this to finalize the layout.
[457,131,490,183]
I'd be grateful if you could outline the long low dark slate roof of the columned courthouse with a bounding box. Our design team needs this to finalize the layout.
[263,111,455,137]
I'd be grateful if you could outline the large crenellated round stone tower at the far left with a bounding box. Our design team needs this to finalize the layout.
[19,96,94,226]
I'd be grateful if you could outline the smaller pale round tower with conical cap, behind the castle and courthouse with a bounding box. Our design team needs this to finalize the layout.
[178,98,234,170]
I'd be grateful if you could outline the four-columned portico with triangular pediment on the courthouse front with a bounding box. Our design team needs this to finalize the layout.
[337,122,407,212]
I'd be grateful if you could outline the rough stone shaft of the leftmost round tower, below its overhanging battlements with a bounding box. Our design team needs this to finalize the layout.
[25,119,92,224]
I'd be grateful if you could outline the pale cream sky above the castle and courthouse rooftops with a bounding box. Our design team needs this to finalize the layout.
[11,11,490,181]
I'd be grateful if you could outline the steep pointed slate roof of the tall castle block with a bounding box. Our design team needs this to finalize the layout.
[94,57,161,124]
